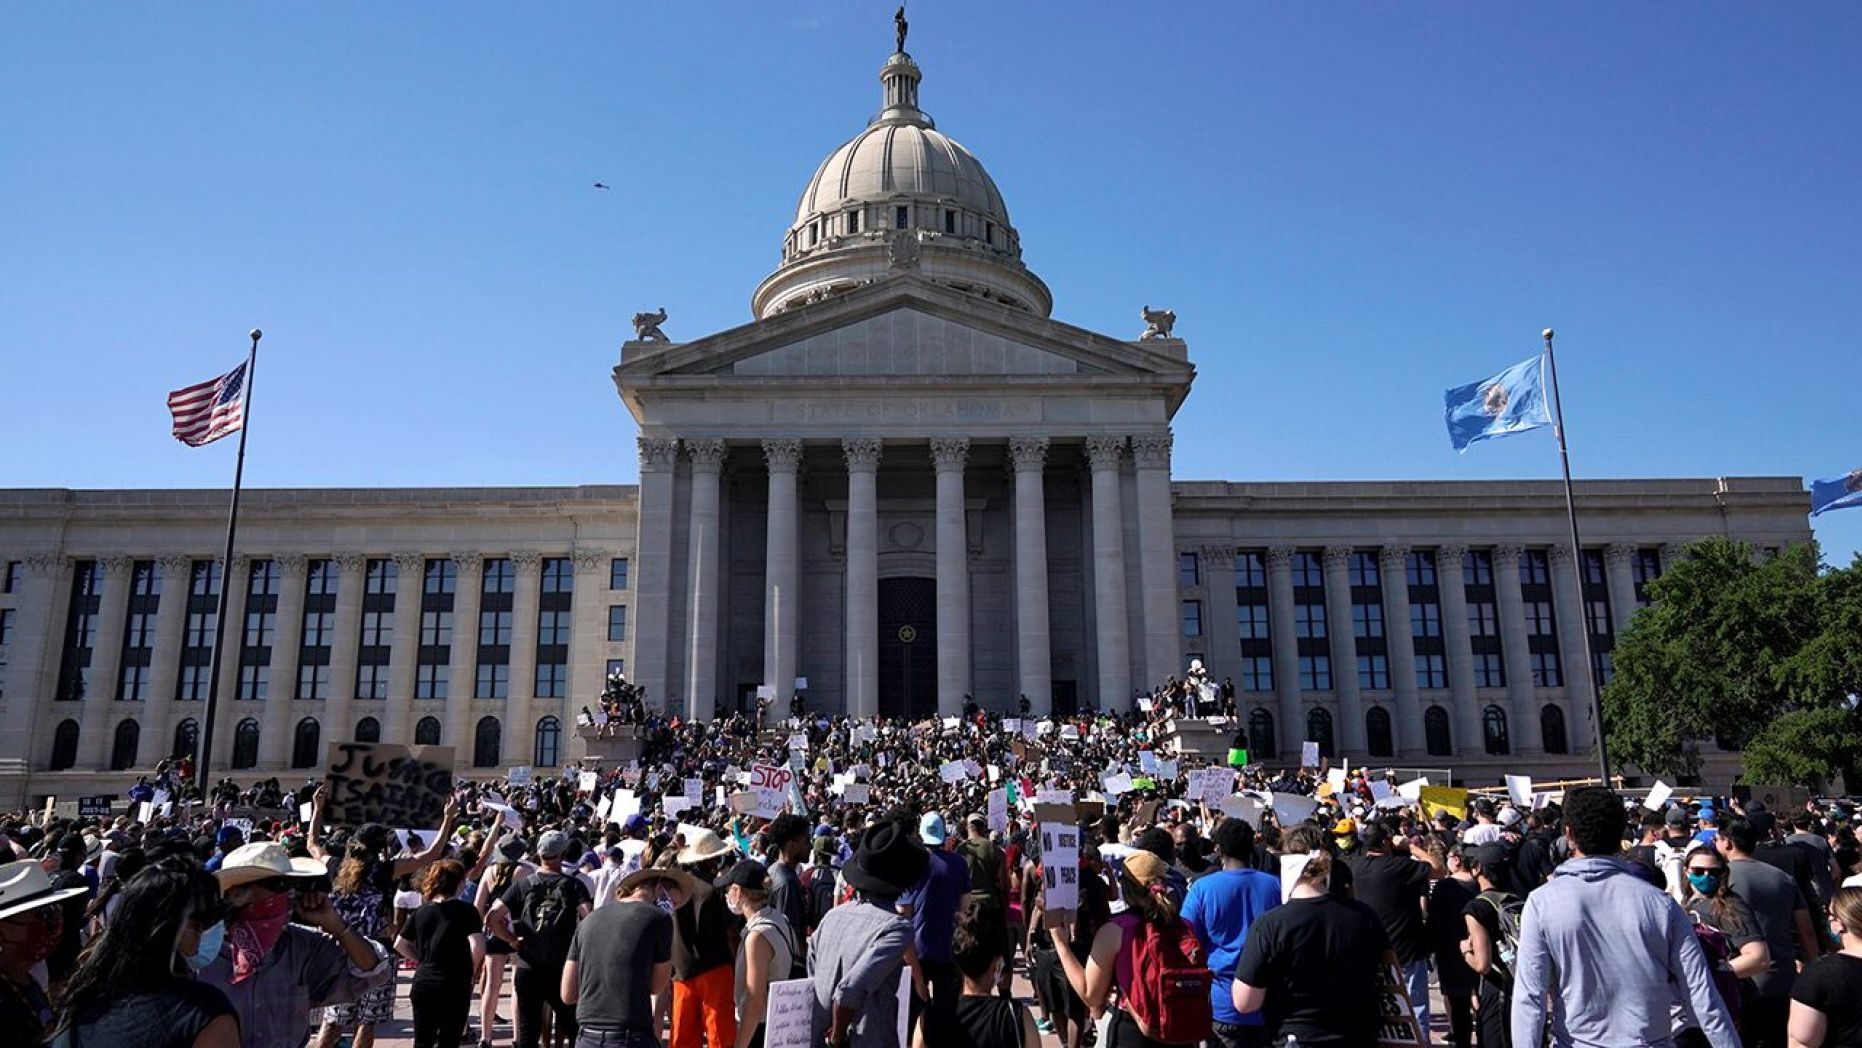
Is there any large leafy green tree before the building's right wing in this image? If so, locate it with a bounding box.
[1603,538,1838,776]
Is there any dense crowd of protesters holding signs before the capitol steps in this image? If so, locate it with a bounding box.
[0,681,1862,1048]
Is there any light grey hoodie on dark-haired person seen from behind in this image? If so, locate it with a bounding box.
[1512,858,1739,1048]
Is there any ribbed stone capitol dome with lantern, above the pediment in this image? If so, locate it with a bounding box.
[750,50,1054,316]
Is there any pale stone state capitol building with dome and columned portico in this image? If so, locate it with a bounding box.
[0,36,1810,804]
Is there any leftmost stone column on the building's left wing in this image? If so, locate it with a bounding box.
[0,553,70,778]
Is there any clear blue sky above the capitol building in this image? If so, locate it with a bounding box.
[0,0,1862,562]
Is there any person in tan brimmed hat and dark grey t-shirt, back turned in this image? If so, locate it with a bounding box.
[562,867,695,1048]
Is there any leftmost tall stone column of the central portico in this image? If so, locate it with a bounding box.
[629,437,680,718]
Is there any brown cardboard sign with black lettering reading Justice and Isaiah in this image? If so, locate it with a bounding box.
[324,743,452,830]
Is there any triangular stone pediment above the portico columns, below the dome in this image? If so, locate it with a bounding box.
[614,277,1194,385]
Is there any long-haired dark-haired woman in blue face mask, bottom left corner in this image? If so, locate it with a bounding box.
[48,858,238,1048]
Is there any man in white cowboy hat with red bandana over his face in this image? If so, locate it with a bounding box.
[201,841,395,1048]
